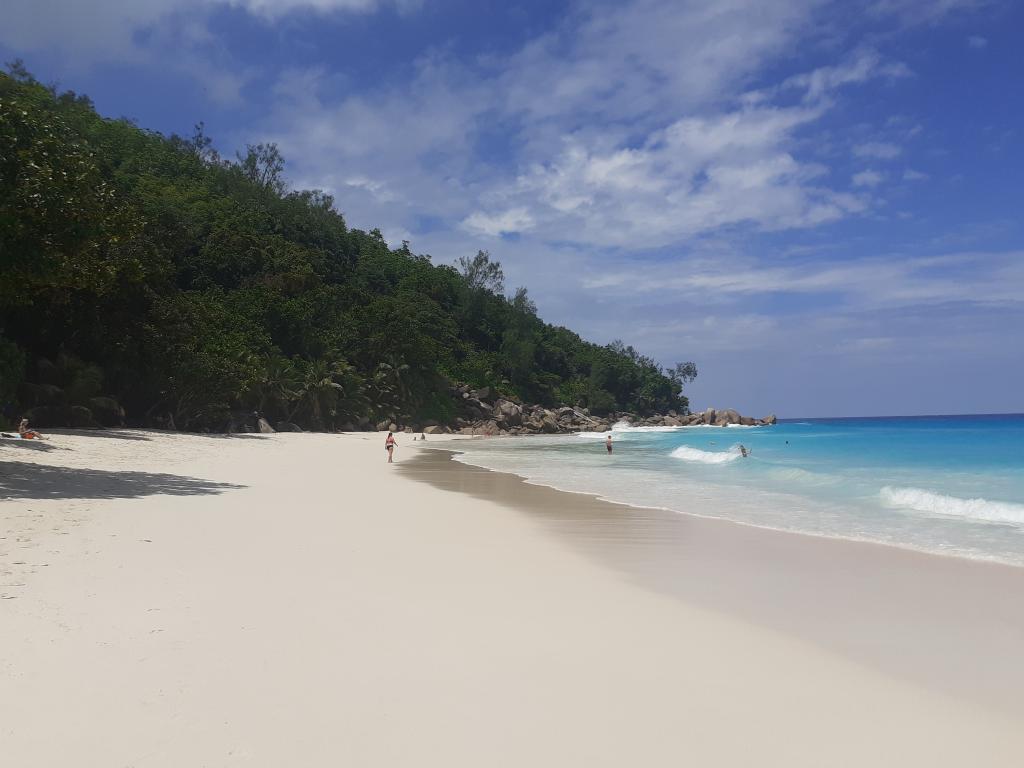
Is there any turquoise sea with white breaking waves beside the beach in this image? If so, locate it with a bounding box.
[459,415,1024,565]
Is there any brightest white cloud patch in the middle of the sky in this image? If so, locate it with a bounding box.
[481,100,864,248]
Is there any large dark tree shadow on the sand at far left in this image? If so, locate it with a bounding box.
[0,462,246,499]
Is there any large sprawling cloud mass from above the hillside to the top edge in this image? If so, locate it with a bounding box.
[256,0,899,250]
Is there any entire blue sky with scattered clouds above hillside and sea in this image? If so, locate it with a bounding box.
[0,0,1024,418]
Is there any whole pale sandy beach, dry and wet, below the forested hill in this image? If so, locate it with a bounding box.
[0,430,1024,767]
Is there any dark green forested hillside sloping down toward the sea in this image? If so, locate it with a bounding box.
[0,66,695,430]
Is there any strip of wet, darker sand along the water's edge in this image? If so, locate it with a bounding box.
[401,446,1024,717]
